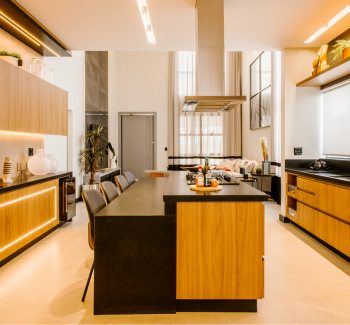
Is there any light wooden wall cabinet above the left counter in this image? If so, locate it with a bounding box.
[0,59,68,136]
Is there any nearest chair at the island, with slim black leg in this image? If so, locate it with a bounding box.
[81,190,106,301]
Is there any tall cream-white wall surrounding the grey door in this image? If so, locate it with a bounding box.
[108,52,169,170]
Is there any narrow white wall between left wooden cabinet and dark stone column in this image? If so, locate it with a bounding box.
[44,51,85,197]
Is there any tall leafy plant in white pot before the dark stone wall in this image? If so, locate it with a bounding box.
[79,125,113,191]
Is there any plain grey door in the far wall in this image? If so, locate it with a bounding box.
[121,115,154,178]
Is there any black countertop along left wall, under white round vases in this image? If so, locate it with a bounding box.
[0,172,72,194]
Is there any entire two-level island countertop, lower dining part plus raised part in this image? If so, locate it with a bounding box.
[96,171,268,217]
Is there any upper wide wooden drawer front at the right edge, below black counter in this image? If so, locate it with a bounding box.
[316,182,350,222]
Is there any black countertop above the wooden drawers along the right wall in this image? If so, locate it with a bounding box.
[285,167,350,186]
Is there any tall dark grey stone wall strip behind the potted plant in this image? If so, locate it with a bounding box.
[85,51,108,168]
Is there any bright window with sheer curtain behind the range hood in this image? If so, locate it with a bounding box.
[177,52,223,157]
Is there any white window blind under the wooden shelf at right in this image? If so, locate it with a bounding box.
[323,83,350,156]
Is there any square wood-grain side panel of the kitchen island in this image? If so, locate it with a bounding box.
[176,202,264,299]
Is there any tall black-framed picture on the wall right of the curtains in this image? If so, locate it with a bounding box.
[250,52,271,130]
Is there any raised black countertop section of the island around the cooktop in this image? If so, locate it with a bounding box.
[164,171,268,203]
